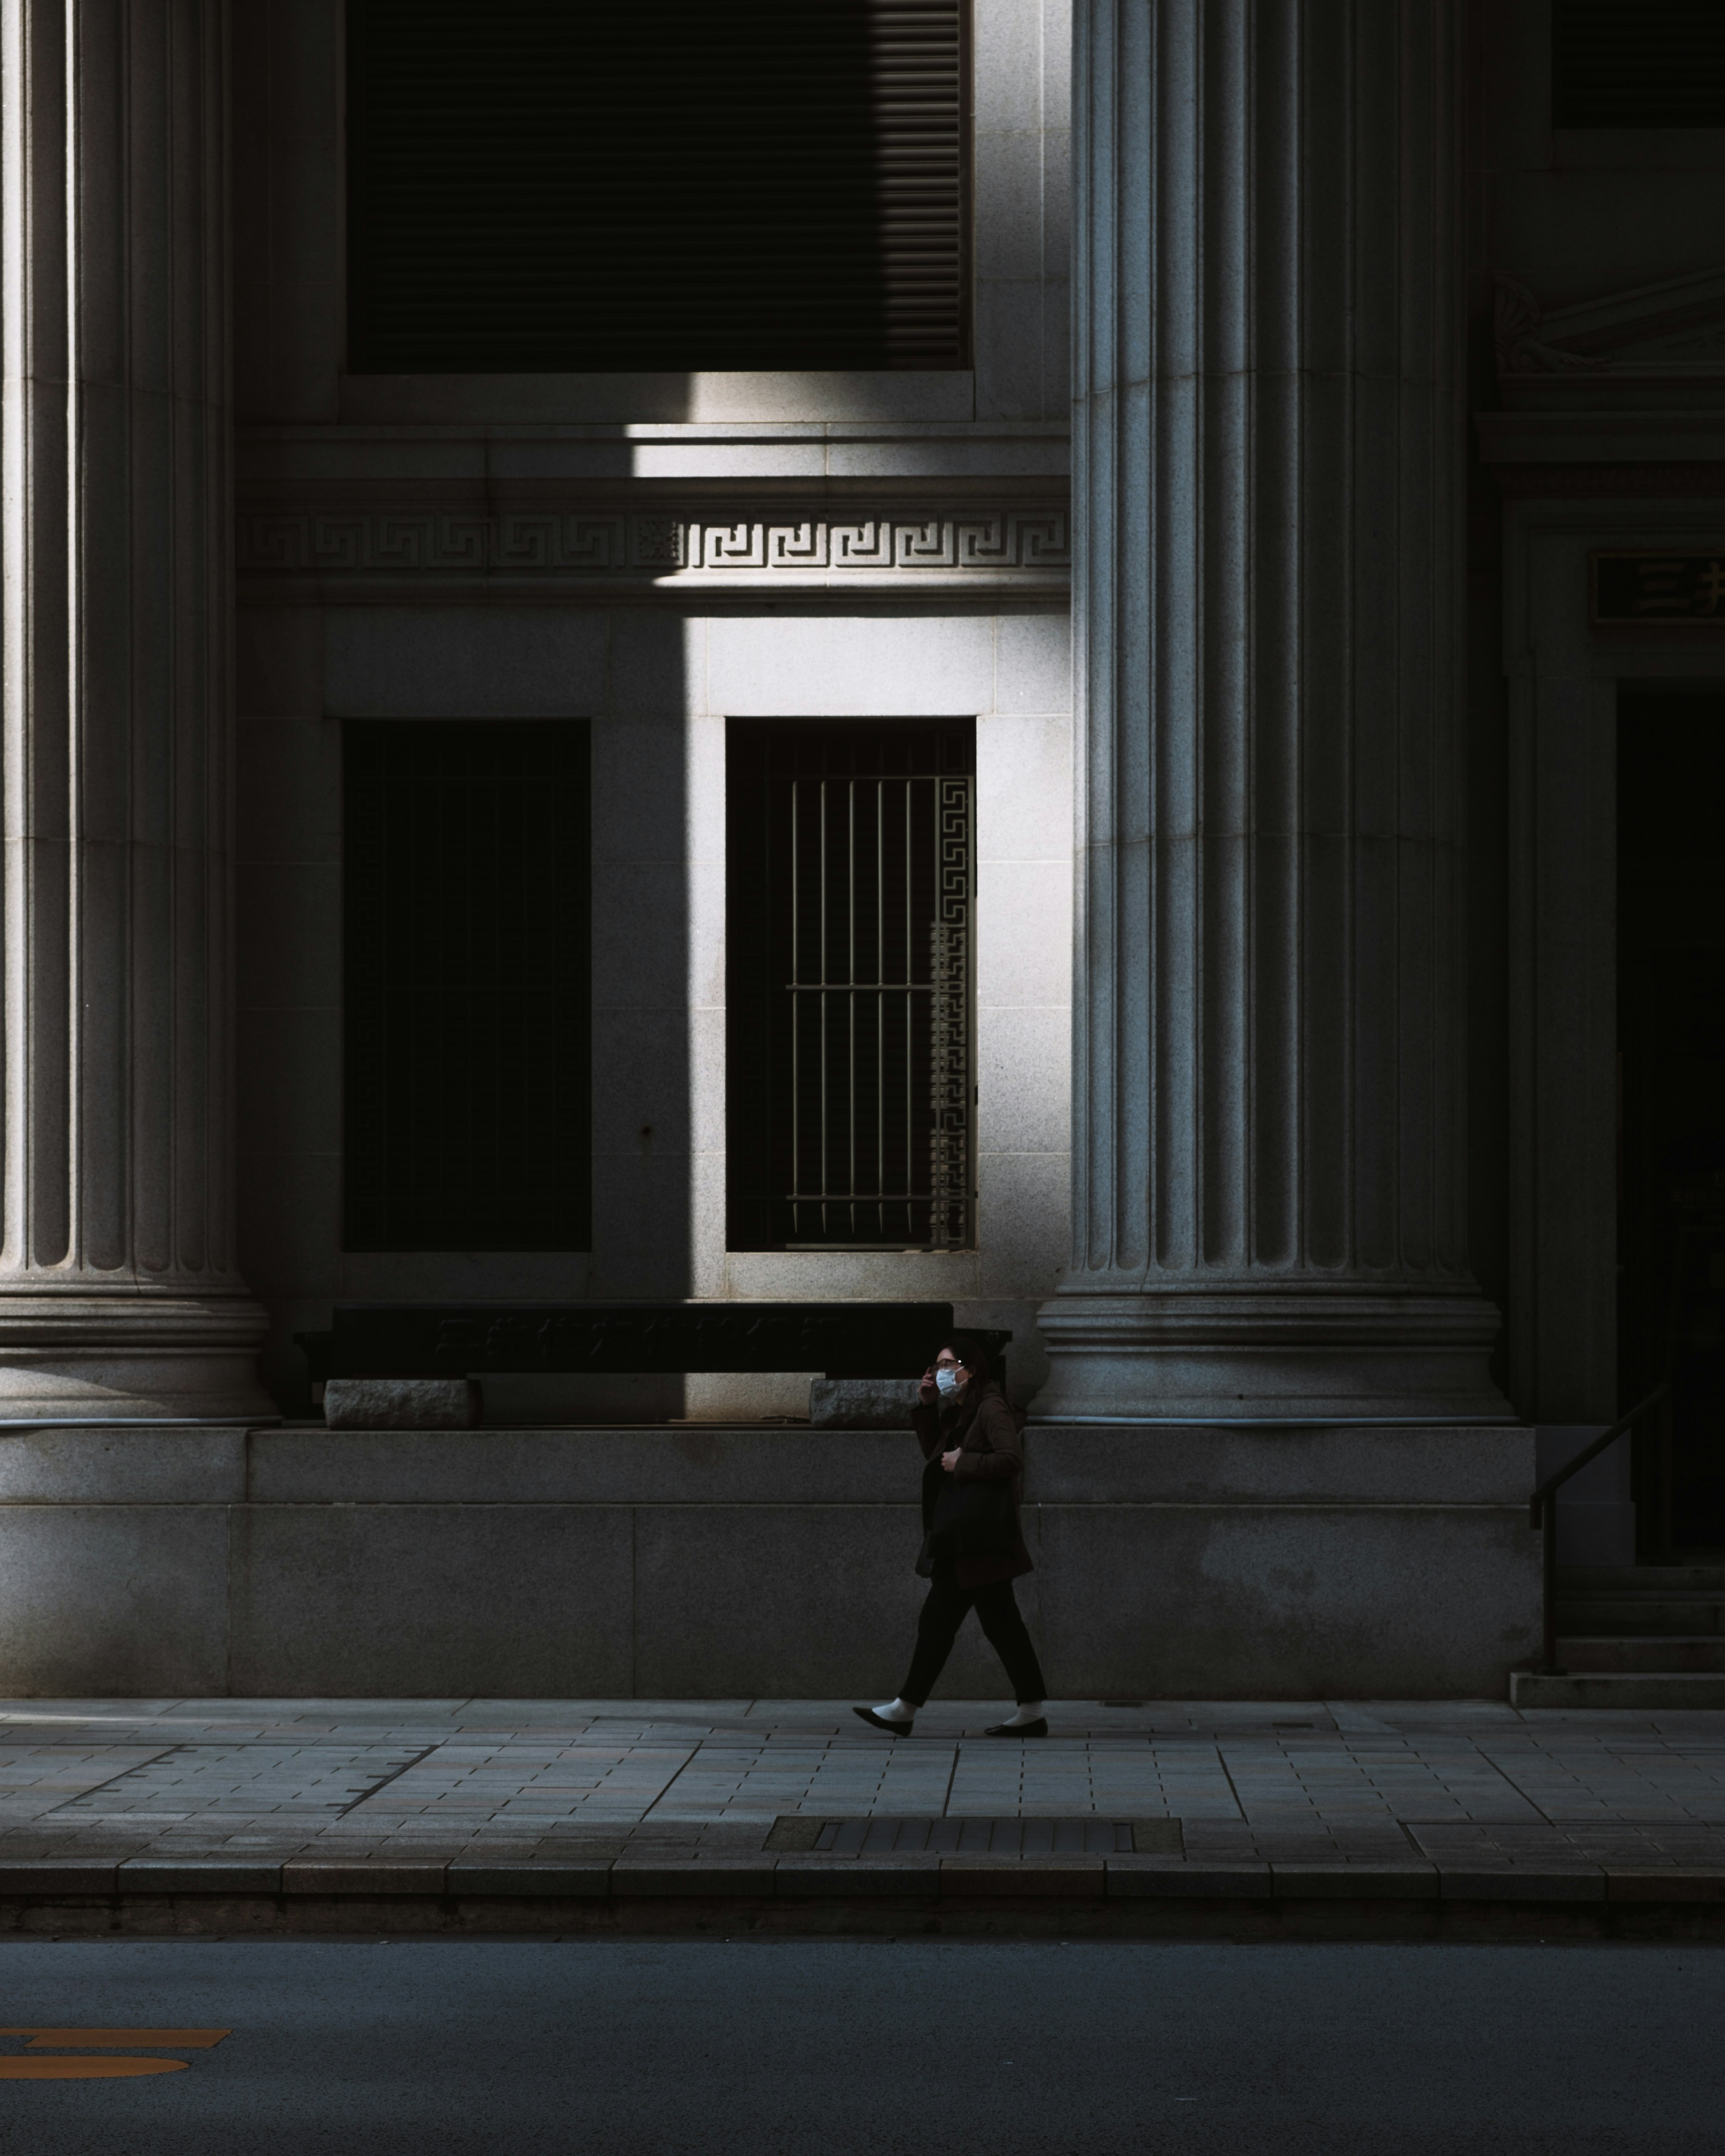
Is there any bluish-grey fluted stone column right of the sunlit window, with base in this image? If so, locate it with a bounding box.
[1037,0,1507,1421]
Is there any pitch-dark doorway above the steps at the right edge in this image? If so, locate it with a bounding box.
[1617,690,1725,1559]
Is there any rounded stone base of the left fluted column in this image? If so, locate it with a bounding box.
[0,1287,280,1423]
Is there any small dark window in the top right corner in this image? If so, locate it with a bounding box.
[1550,0,1725,127]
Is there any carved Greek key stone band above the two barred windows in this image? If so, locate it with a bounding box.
[237,498,1072,601]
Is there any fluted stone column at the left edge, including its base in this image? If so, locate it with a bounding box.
[0,0,270,1418]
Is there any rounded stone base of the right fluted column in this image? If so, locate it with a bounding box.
[1033,1287,1518,1423]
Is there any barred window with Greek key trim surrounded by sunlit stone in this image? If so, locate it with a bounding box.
[727,720,977,1250]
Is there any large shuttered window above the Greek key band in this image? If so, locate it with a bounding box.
[347,0,968,373]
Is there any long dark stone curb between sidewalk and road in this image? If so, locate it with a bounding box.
[0,1856,1725,1904]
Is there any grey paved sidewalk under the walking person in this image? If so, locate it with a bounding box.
[0,1699,1725,1871]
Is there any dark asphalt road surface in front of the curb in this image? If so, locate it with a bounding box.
[0,1940,1725,2156]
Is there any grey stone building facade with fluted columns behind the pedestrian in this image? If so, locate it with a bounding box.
[0,0,1725,1697]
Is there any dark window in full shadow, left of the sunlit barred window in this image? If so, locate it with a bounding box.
[343,720,591,1250]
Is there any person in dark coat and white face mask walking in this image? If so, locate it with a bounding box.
[852,1332,1048,1738]
